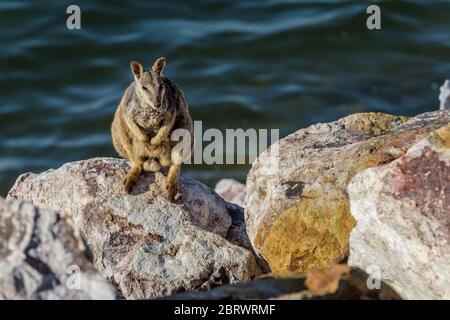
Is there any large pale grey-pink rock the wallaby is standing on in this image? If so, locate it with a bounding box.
[9,158,259,299]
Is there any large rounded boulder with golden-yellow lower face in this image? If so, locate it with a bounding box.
[245,111,450,272]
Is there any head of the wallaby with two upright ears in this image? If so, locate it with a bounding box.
[130,57,166,109]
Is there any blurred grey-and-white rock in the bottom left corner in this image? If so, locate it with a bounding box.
[0,198,116,299]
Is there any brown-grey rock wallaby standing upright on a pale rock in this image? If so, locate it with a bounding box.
[111,57,194,201]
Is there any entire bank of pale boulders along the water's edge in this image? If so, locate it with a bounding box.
[0,110,450,299]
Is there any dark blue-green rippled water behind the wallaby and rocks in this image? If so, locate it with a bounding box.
[0,0,450,196]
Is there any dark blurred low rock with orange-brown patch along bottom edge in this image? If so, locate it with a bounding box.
[165,265,400,300]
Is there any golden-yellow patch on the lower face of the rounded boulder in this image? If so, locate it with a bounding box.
[255,191,354,272]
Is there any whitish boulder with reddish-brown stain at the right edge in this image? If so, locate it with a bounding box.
[348,124,450,299]
